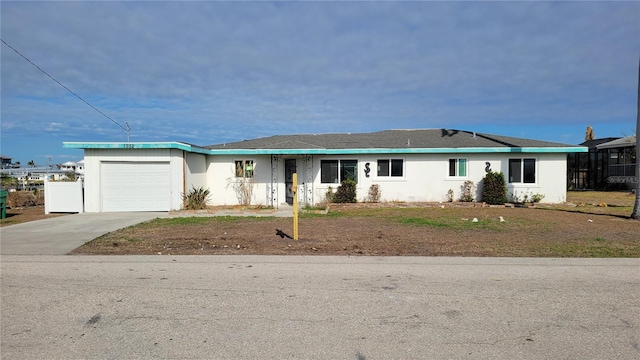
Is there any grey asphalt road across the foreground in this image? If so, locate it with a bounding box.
[0,256,640,360]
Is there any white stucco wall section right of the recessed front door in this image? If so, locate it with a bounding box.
[314,154,566,203]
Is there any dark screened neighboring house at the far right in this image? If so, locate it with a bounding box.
[567,136,636,190]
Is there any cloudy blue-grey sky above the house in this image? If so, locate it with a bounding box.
[0,0,640,165]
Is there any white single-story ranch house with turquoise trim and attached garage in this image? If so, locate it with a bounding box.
[64,129,588,212]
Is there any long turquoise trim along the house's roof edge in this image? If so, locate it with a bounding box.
[62,142,589,155]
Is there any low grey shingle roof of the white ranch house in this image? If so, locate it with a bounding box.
[205,129,574,150]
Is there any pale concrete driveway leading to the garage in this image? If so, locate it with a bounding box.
[0,212,168,255]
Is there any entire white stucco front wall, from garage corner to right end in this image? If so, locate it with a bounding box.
[202,153,566,207]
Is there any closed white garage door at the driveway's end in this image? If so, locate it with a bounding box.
[101,162,171,212]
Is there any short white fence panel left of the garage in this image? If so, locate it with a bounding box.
[44,178,84,214]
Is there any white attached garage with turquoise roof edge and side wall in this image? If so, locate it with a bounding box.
[64,142,209,213]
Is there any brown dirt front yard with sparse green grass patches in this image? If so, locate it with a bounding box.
[74,193,640,257]
